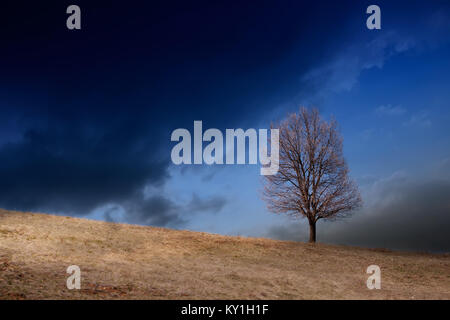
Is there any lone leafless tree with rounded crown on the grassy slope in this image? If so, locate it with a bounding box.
[263,108,362,242]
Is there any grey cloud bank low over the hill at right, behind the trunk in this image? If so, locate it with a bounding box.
[268,175,450,252]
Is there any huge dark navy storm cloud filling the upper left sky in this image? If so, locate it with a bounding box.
[0,1,352,225]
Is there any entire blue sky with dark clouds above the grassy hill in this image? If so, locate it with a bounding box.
[0,1,450,252]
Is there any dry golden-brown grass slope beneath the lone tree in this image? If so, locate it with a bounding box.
[0,210,450,299]
